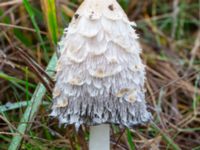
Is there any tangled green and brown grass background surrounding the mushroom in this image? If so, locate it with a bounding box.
[0,0,200,150]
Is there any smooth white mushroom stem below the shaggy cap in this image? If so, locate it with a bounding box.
[89,124,110,150]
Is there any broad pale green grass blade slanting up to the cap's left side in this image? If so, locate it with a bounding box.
[9,54,57,150]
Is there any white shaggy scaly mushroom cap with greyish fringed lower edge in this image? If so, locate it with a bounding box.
[51,0,151,128]
